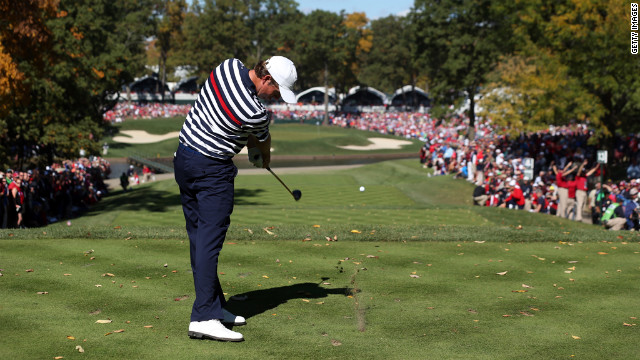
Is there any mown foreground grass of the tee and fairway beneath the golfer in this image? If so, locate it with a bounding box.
[0,160,640,359]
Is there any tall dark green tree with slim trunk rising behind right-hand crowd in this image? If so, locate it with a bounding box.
[412,0,511,139]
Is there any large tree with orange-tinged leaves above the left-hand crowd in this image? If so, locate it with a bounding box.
[0,0,150,167]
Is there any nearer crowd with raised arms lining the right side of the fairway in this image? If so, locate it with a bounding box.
[420,129,640,230]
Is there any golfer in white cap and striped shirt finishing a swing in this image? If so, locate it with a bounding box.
[173,56,297,341]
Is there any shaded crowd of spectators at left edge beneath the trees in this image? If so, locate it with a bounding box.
[0,157,111,229]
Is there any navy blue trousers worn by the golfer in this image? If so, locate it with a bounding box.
[173,144,238,321]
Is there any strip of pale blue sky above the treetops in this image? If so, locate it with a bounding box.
[296,0,413,20]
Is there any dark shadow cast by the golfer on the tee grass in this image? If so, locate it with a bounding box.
[227,283,355,318]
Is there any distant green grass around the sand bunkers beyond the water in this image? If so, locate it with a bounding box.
[105,117,422,157]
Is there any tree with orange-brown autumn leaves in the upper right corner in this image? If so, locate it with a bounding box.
[515,0,640,138]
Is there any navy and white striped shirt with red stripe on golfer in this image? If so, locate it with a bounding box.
[179,59,271,160]
